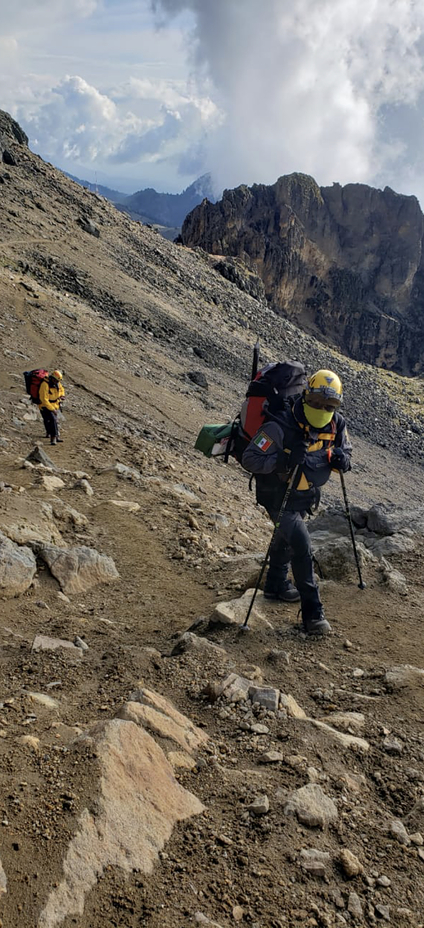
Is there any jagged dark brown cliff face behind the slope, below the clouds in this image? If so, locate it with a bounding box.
[181,174,424,374]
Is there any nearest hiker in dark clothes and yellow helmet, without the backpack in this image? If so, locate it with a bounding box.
[242,370,352,635]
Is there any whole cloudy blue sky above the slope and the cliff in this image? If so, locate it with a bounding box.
[0,0,424,206]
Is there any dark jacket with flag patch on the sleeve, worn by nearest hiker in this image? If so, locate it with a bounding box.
[242,399,352,514]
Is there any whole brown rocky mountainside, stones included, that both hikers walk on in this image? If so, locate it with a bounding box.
[0,114,424,928]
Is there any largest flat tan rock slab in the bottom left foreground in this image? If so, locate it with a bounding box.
[37,719,204,928]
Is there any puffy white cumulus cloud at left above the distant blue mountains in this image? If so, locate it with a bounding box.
[18,76,218,185]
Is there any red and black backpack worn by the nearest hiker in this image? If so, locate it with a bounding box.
[227,361,307,463]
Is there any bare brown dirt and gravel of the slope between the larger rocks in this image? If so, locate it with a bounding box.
[0,130,424,928]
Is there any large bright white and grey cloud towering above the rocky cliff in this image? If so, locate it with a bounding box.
[152,0,424,202]
